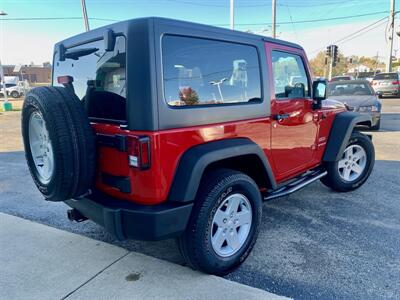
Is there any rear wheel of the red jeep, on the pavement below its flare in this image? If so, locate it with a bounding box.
[178,169,262,275]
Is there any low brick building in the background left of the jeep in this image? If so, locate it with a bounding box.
[3,65,51,84]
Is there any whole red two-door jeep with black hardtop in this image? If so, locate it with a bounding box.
[22,18,375,274]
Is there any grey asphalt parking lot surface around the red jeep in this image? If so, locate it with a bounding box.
[0,99,400,299]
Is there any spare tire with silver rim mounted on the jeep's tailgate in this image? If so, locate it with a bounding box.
[21,87,96,201]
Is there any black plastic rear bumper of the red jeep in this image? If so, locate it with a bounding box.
[65,196,193,241]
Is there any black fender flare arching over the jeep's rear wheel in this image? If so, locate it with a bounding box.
[168,138,277,202]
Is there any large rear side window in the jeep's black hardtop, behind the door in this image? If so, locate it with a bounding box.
[162,35,261,106]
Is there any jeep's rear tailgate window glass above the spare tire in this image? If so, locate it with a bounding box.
[53,36,126,122]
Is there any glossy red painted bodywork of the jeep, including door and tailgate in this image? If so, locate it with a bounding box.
[92,43,343,205]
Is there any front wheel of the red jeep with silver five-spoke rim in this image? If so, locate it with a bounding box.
[321,132,375,192]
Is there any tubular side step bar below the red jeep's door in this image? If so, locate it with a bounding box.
[264,170,328,201]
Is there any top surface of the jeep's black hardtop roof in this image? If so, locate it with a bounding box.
[56,17,303,49]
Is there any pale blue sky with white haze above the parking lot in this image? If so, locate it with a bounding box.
[0,0,400,64]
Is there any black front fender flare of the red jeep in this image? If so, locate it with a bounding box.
[322,111,371,161]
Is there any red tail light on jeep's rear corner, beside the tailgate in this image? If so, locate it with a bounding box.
[127,136,151,170]
